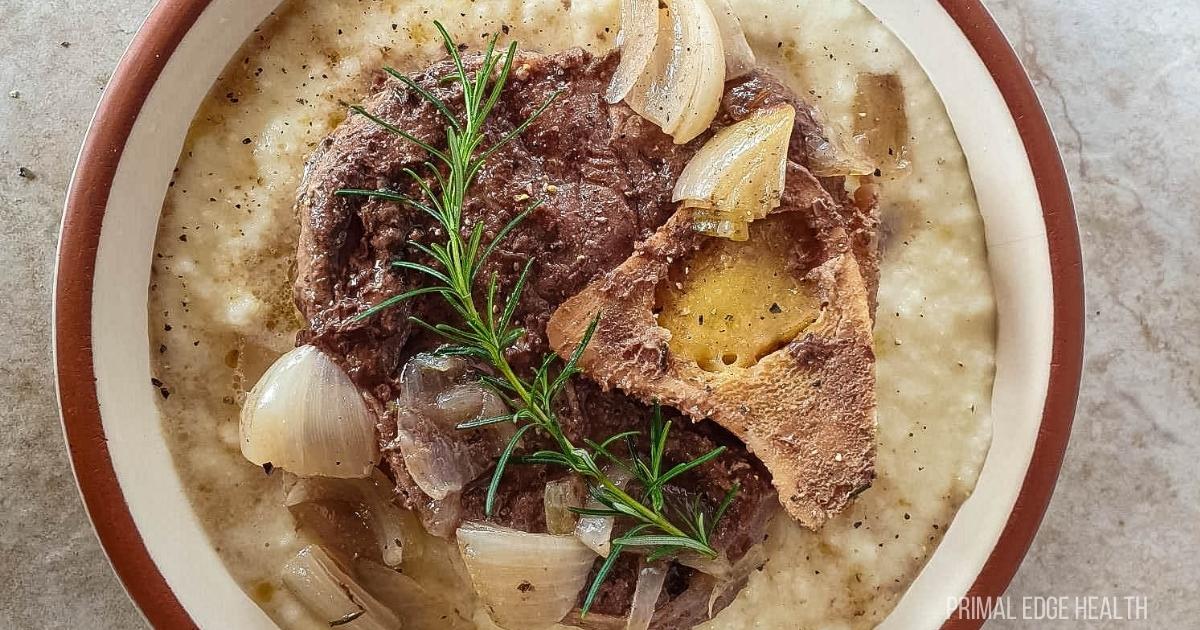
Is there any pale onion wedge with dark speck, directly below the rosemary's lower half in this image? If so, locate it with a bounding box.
[457,522,596,630]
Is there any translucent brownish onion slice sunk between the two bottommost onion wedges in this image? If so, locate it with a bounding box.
[354,560,475,630]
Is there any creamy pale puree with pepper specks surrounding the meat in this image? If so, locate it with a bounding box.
[150,0,995,629]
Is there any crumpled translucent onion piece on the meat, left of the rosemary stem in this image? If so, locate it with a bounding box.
[394,354,515,502]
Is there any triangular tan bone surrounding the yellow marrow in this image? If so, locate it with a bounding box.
[548,206,875,529]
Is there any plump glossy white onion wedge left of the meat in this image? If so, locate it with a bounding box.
[241,346,379,478]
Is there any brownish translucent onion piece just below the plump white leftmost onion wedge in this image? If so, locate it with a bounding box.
[283,470,420,566]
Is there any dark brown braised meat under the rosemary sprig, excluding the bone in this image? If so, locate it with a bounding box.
[295,49,874,628]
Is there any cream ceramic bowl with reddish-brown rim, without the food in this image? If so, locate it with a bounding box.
[54,0,1084,630]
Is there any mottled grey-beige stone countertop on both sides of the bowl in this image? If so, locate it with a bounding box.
[0,0,1200,629]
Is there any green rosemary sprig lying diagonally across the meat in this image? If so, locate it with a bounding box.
[337,22,738,614]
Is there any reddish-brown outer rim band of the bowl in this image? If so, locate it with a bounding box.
[53,0,1085,630]
